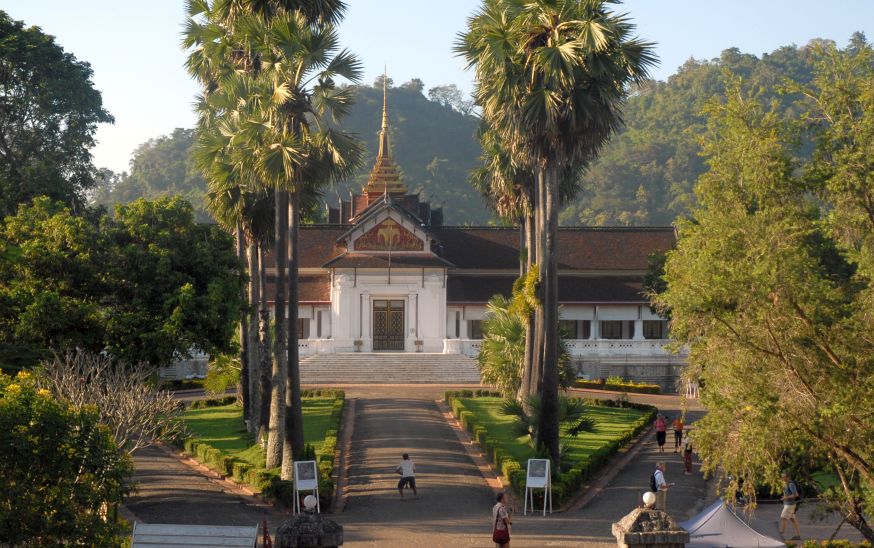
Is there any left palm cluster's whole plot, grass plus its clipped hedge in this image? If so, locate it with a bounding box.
[182,390,345,507]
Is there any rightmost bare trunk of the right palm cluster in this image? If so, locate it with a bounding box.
[537,160,559,466]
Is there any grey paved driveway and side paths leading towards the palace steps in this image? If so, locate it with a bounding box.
[127,385,857,548]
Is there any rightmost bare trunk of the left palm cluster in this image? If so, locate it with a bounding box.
[282,189,304,479]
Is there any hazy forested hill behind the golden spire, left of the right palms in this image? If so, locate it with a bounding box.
[92,80,490,224]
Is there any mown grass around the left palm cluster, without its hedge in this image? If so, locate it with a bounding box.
[184,398,339,468]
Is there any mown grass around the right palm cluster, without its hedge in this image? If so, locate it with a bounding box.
[461,398,645,466]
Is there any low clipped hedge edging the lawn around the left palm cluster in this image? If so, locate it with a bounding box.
[182,389,346,508]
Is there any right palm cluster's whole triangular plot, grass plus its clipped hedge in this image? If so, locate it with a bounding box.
[446,391,656,506]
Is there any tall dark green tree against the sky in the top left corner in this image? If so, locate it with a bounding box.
[0,10,113,217]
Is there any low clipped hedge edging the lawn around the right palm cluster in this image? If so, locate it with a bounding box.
[445,390,657,506]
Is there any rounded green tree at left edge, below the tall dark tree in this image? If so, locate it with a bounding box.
[0,197,109,370]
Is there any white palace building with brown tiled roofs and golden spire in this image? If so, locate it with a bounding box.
[280,83,682,386]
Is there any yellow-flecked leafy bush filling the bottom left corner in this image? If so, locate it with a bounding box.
[0,372,133,546]
